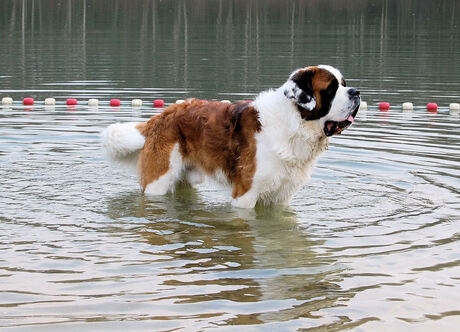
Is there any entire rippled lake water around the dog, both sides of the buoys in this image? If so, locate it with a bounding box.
[0,0,460,331]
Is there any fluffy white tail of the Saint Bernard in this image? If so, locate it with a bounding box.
[102,122,145,162]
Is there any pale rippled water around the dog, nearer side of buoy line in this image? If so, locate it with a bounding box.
[0,107,460,331]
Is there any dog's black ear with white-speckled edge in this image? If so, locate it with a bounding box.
[284,69,316,111]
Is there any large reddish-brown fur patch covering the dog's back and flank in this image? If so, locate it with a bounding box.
[136,99,261,198]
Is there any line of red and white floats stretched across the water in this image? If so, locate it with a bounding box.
[2,97,460,115]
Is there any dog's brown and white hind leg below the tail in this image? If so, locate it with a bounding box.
[140,143,184,195]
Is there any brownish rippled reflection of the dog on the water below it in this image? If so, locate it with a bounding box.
[108,188,340,324]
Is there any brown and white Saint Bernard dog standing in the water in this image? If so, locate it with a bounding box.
[102,65,361,208]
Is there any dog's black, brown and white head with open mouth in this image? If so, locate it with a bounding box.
[282,65,361,136]
